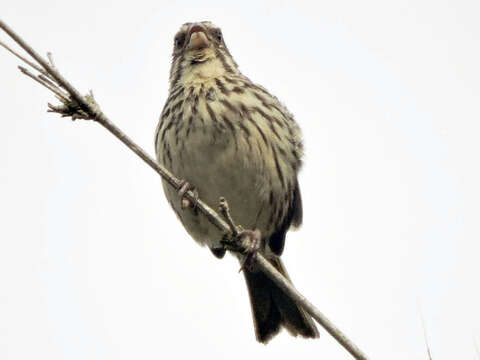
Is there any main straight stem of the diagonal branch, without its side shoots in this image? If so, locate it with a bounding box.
[0,20,367,360]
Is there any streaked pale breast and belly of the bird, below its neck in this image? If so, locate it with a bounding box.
[156,72,301,253]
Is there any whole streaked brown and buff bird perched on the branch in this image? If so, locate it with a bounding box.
[155,21,319,344]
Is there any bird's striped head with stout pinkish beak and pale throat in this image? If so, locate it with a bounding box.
[170,21,238,88]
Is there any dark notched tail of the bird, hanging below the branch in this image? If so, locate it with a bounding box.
[244,258,319,344]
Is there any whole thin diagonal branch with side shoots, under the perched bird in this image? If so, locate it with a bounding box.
[0,20,367,360]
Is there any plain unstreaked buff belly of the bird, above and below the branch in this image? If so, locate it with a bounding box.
[164,130,270,247]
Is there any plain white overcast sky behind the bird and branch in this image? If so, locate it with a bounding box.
[0,0,480,360]
